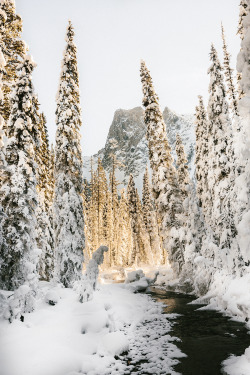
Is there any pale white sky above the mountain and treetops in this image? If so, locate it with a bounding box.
[16,0,240,155]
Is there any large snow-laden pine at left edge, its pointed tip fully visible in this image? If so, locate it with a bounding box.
[0,56,39,308]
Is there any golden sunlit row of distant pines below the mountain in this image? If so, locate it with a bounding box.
[84,155,166,268]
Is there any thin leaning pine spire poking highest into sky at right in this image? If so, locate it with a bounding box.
[221,24,239,116]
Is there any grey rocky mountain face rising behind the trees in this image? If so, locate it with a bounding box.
[84,107,195,192]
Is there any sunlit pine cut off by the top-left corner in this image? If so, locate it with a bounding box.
[0,0,27,125]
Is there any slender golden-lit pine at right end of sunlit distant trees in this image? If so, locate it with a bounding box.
[142,168,163,264]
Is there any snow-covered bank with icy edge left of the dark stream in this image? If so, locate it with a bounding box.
[0,282,183,375]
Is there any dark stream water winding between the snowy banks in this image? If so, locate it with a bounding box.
[149,288,250,375]
